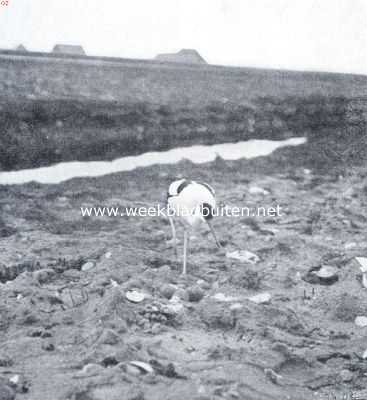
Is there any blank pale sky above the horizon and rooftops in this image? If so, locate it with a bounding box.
[0,0,367,74]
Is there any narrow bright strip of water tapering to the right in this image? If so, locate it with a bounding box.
[0,137,307,185]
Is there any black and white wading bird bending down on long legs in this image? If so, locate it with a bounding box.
[167,179,221,274]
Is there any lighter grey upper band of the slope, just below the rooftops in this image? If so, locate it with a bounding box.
[0,52,367,107]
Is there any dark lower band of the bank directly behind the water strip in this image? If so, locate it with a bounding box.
[0,96,367,170]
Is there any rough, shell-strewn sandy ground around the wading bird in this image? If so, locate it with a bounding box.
[0,147,367,400]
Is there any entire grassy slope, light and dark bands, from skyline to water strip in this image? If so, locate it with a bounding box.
[0,54,367,170]
